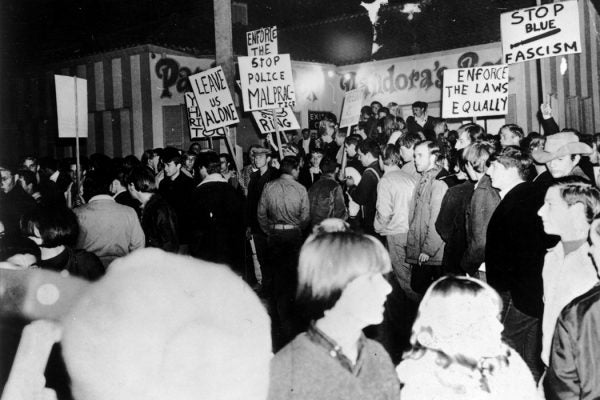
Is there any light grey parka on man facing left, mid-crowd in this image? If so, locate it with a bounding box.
[406,168,448,265]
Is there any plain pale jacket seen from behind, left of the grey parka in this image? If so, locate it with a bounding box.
[374,167,417,236]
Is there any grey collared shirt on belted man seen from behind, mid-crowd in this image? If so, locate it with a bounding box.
[257,174,310,233]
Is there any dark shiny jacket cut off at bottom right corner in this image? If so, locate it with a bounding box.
[544,284,600,400]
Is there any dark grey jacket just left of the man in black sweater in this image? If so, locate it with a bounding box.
[460,175,500,276]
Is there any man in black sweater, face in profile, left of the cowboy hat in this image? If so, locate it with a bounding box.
[485,146,546,380]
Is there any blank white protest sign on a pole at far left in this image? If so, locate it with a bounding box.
[54,75,88,138]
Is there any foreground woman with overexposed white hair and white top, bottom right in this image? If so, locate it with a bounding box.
[396,277,537,400]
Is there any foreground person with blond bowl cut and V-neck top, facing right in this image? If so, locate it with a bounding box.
[269,229,400,400]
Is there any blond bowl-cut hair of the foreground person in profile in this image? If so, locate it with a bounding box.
[297,232,392,320]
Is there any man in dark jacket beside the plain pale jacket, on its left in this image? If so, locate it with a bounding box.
[349,139,383,236]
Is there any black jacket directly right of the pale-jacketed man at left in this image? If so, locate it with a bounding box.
[142,193,179,253]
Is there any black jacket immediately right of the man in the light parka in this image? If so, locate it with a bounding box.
[435,181,475,275]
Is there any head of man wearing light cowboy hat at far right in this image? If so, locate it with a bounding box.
[531,131,592,181]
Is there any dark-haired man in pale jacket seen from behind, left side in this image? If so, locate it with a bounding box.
[74,171,146,267]
